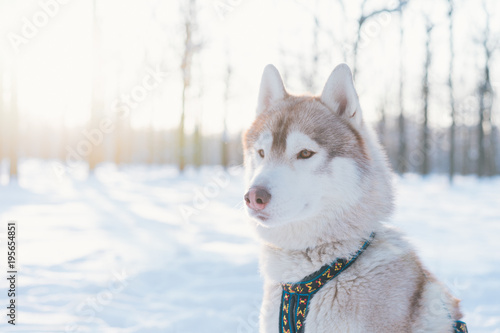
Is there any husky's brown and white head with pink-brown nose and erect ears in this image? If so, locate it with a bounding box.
[243,65,392,247]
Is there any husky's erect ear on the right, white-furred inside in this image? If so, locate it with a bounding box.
[321,64,362,125]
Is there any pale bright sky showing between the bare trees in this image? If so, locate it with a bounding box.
[0,0,500,133]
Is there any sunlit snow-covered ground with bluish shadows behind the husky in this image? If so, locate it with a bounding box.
[0,160,500,333]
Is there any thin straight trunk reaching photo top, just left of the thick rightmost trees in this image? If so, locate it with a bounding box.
[448,0,456,183]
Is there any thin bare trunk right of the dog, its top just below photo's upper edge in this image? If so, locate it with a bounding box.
[420,17,434,175]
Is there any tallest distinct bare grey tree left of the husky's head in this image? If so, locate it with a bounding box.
[179,0,201,171]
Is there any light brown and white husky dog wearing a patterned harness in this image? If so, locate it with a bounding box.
[243,64,462,333]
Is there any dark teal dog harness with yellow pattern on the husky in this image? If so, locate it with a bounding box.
[279,233,468,333]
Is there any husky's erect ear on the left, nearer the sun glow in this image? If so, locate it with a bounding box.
[257,65,287,115]
